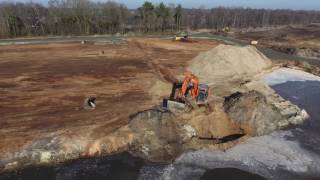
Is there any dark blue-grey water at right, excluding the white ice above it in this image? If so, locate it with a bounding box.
[272,81,320,154]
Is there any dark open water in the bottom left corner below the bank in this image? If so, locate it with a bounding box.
[0,153,147,180]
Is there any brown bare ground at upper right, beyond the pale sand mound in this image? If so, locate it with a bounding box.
[231,24,320,60]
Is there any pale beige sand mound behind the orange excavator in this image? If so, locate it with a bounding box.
[188,45,271,83]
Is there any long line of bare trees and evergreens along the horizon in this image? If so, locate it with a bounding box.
[0,0,320,38]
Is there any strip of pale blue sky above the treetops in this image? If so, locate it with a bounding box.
[0,0,320,10]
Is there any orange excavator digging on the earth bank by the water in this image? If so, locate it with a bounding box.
[163,71,209,111]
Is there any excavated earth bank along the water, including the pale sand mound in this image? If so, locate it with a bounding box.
[0,45,308,171]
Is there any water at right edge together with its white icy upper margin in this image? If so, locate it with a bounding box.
[265,68,320,179]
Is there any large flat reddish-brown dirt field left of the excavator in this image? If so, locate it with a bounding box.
[0,39,217,155]
